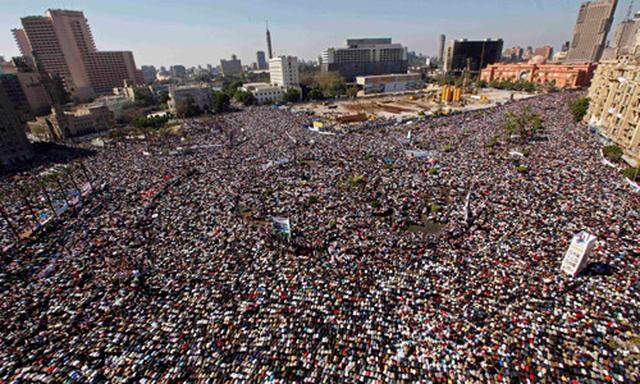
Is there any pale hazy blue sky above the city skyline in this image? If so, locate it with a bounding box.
[0,0,630,66]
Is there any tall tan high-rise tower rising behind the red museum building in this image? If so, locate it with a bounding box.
[565,0,618,63]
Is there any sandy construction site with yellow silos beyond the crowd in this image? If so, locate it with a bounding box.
[292,85,534,126]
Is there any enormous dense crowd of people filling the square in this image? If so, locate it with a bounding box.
[0,94,640,383]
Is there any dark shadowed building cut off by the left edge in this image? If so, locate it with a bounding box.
[0,80,33,167]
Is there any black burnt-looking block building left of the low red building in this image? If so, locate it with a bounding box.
[444,39,503,75]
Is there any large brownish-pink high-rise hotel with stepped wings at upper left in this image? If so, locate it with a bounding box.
[13,9,143,100]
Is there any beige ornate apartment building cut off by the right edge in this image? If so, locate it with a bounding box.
[585,57,640,162]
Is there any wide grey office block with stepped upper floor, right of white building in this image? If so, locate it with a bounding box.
[321,38,408,81]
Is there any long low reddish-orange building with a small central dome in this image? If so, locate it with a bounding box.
[480,60,596,89]
